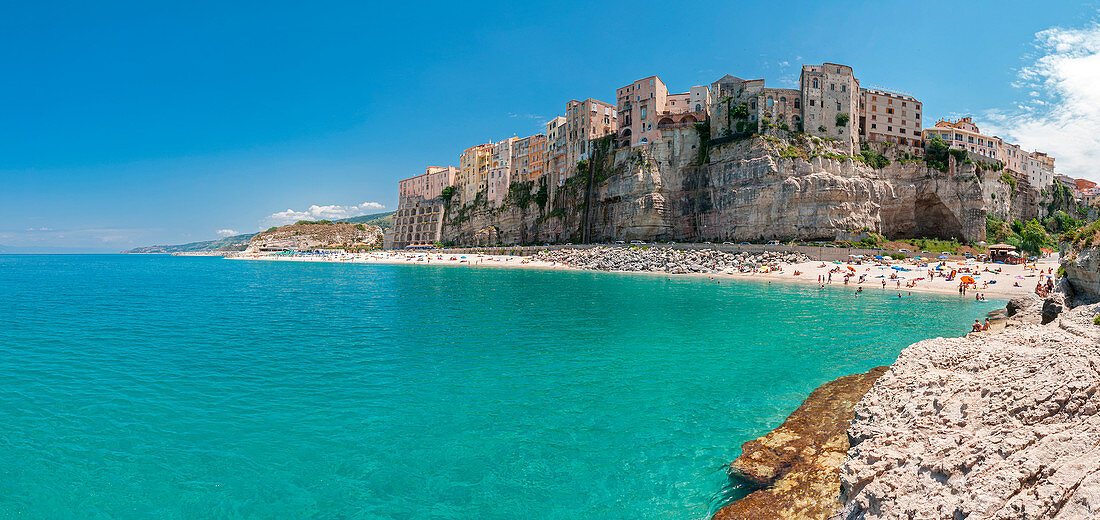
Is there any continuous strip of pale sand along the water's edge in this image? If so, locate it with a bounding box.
[226,252,1058,300]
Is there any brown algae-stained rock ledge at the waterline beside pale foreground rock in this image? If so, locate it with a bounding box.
[714,366,887,520]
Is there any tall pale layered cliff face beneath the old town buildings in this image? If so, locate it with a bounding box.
[435,129,1021,244]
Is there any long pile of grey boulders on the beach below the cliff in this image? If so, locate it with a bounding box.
[534,247,810,274]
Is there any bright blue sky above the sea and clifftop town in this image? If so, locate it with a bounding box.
[0,1,1100,251]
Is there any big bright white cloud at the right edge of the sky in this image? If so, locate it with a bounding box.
[983,23,1100,180]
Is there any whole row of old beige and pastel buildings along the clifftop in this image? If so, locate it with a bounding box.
[387,63,1082,247]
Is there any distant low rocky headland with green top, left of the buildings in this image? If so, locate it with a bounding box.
[245,220,382,253]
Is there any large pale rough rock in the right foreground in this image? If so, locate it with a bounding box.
[837,301,1100,520]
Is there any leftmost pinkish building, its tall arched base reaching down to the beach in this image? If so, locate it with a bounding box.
[384,166,459,248]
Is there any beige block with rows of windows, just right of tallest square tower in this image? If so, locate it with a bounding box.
[859,88,924,154]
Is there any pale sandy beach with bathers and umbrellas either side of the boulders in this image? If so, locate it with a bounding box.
[231,251,1058,299]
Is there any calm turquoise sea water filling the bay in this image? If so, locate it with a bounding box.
[0,252,1001,519]
